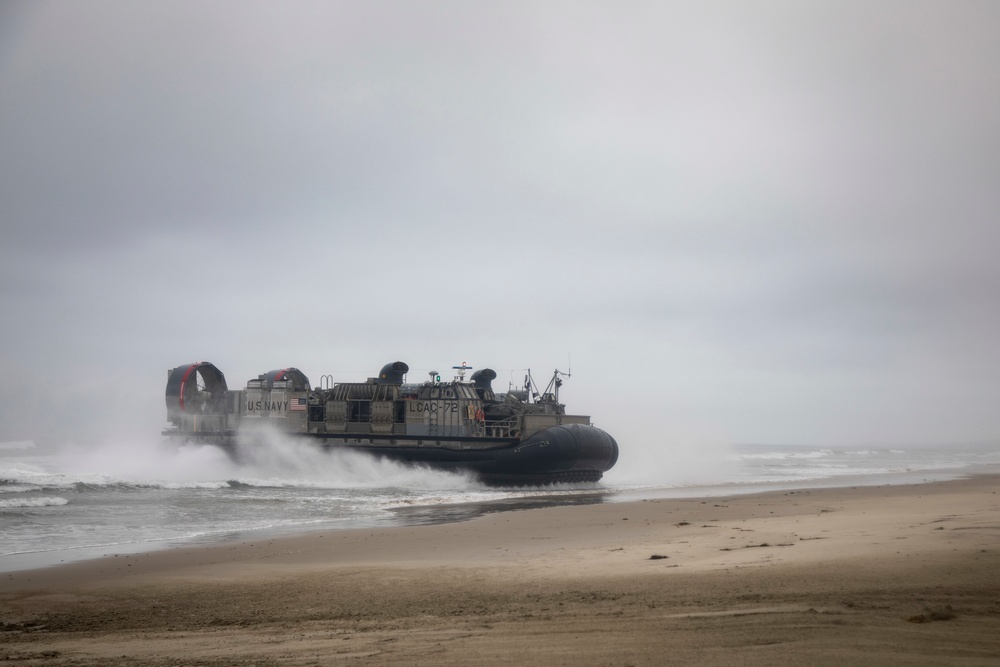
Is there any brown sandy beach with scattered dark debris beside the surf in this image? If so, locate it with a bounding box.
[0,475,1000,666]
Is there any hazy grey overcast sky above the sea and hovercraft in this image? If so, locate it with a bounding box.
[0,0,1000,461]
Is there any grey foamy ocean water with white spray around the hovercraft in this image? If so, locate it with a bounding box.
[0,440,1000,572]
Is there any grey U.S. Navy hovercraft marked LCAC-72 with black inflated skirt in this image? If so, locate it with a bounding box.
[163,361,618,486]
